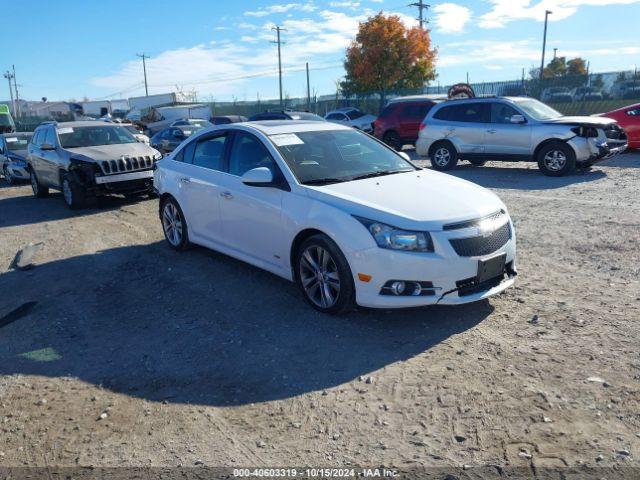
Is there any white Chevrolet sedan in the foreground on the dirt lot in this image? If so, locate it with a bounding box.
[154,121,516,313]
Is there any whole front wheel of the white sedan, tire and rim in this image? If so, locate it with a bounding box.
[294,235,356,315]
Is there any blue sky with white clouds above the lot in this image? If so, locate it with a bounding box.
[0,0,640,101]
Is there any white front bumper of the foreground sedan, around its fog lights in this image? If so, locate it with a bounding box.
[348,225,516,308]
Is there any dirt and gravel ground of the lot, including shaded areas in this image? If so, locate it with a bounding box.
[0,154,640,472]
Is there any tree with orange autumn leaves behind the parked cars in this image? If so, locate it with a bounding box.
[343,12,436,109]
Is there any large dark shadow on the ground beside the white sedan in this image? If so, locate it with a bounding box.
[0,242,492,405]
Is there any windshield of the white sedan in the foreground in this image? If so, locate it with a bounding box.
[270,130,416,185]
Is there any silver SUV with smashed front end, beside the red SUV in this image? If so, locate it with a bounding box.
[416,97,627,177]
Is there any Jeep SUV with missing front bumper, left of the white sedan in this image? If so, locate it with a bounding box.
[27,121,162,209]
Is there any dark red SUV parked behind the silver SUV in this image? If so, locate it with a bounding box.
[373,97,436,150]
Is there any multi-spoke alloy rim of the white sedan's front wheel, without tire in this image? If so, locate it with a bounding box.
[299,245,340,308]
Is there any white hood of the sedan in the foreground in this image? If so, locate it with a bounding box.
[307,170,506,231]
